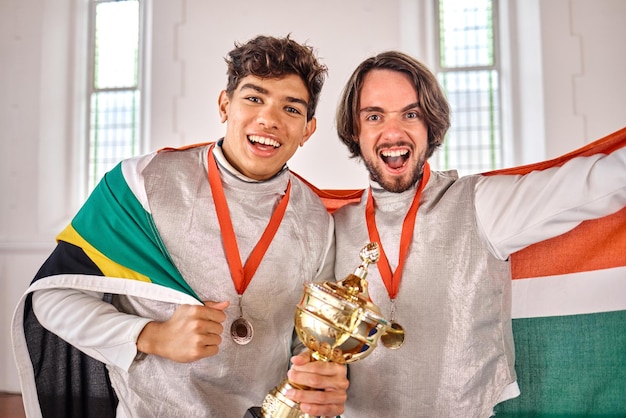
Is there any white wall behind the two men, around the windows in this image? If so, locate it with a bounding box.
[0,0,626,391]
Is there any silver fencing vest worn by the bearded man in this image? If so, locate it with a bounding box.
[334,171,515,418]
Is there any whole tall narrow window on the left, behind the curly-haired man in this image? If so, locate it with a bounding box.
[88,0,142,190]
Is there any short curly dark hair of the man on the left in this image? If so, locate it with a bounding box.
[224,35,328,121]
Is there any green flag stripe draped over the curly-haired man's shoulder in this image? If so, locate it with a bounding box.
[72,164,199,300]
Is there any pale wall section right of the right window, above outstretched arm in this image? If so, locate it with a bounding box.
[540,0,626,157]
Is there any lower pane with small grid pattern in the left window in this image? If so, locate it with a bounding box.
[89,90,139,187]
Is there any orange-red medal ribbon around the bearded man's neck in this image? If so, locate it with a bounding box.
[365,162,430,300]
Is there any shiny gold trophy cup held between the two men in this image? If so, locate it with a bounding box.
[261,242,404,418]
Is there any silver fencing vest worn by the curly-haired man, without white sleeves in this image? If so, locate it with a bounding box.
[109,143,332,417]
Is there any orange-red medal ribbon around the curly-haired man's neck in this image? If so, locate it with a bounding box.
[208,145,291,295]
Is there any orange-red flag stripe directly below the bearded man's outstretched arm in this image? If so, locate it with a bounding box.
[511,208,626,279]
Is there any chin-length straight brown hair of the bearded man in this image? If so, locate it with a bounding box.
[336,51,450,159]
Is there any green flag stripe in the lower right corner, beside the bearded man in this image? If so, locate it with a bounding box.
[495,311,626,418]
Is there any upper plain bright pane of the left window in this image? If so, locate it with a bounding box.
[94,0,139,89]
